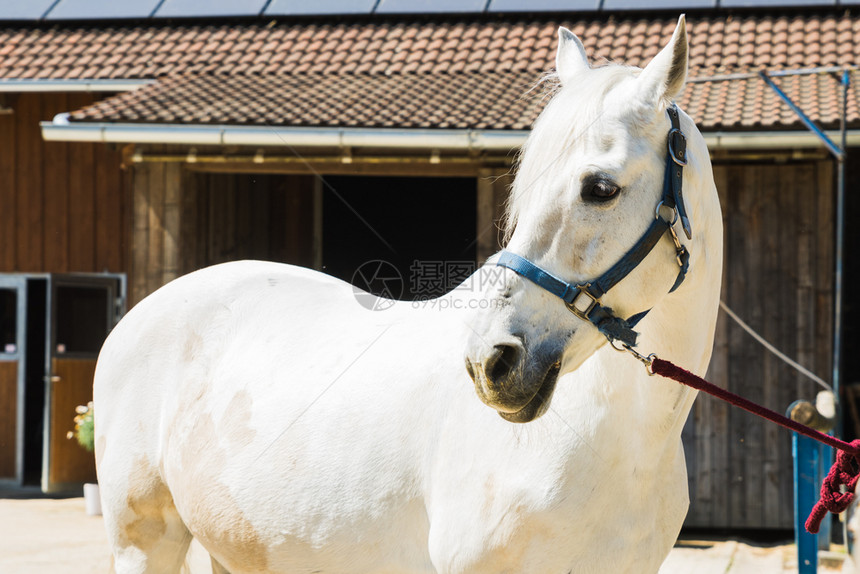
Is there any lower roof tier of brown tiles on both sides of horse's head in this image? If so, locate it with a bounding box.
[69,71,860,130]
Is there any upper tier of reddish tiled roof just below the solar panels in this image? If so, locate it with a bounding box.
[0,11,860,79]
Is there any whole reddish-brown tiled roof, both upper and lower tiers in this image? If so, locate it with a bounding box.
[6,10,860,129]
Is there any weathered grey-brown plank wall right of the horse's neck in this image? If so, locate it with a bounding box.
[684,161,834,529]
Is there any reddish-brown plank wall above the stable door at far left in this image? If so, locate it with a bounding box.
[0,93,128,273]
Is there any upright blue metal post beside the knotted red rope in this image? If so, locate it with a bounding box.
[791,433,828,574]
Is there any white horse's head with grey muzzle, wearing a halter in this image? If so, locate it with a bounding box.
[466,16,719,422]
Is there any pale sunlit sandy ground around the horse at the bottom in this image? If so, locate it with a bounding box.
[0,495,854,574]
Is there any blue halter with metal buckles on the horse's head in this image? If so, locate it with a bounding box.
[496,104,692,347]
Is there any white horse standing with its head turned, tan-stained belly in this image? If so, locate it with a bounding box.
[95,18,722,574]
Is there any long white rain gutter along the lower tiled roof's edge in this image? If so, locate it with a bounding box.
[41,114,860,151]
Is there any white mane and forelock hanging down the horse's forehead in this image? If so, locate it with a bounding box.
[501,63,640,244]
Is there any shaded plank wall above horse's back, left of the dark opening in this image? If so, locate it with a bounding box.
[130,168,316,304]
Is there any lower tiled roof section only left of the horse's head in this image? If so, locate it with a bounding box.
[69,72,541,130]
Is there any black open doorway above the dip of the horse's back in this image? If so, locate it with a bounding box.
[322,176,477,300]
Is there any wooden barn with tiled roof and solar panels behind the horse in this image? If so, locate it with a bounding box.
[0,0,860,529]
